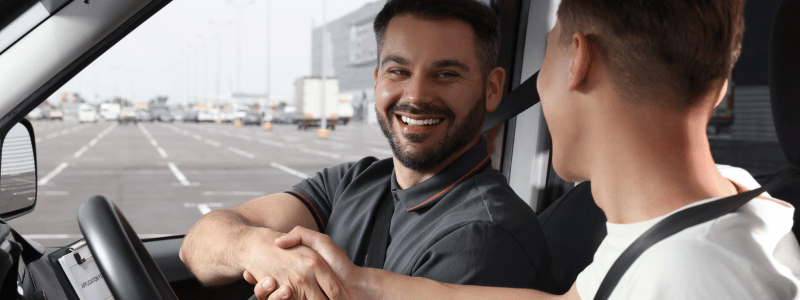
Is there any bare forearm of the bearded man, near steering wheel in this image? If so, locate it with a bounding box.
[180,209,277,285]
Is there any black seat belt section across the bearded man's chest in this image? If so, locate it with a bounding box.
[364,191,394,269]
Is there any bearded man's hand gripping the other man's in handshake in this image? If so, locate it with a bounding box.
[241,229,349,299]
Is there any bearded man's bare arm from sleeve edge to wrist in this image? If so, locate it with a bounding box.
[180,193,319,285]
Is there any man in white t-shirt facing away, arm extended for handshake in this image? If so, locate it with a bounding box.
[256,0,800,300]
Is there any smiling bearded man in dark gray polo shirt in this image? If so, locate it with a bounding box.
[180,0,549,296]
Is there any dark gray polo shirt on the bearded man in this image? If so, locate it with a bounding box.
[288,137,550,289]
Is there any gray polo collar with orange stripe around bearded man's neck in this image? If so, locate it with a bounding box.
[391,135,491,211]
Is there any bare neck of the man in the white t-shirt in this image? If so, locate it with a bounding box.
[589,102,736,224]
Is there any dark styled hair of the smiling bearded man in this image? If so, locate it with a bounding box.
[373,0,500,75]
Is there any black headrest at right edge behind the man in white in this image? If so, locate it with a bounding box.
[769,0,800,168]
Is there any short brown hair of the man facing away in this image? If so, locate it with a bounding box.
[558,0,744,108]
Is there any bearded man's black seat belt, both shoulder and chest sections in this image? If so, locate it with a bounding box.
[364,71,539,269]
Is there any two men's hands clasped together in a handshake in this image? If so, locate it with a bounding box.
[243,227,357,300]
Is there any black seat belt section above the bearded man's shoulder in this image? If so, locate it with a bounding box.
[483,71,539,131]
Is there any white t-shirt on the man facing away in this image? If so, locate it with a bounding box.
[576,165,800,300]
